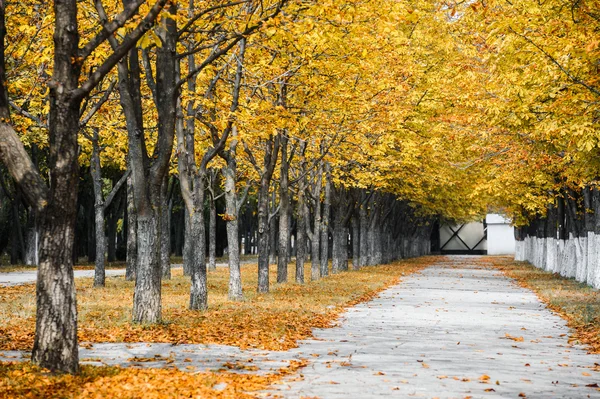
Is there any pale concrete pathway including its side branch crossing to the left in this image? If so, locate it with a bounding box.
[0,257,600,399]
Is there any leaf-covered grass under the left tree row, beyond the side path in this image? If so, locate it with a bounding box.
[0,257,436,350]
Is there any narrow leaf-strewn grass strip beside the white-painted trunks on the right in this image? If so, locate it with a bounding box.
[486,257,600,353]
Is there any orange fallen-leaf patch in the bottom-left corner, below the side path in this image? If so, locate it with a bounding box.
[0,361,306,399]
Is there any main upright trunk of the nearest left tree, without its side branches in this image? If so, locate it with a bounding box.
[31,0,81,373]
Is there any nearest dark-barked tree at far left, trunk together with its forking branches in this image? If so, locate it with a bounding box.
[0,0,166,373]
